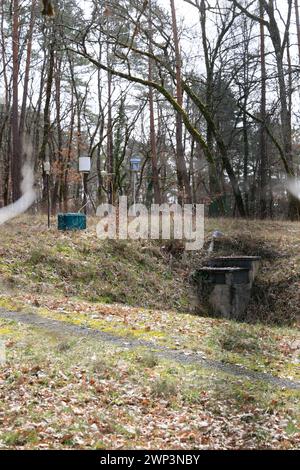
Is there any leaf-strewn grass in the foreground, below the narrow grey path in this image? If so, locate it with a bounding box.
[0,320,300,450]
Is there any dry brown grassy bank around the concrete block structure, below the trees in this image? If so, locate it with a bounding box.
[0,217,300,326]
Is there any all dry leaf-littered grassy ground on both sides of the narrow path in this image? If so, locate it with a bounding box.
[0,218,300,449]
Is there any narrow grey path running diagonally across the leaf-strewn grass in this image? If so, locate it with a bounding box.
[0,308,300,390]
